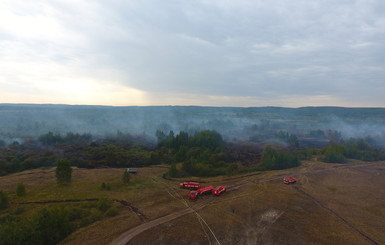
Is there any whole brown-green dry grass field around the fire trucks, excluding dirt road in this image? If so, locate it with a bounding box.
[0,161,385,244]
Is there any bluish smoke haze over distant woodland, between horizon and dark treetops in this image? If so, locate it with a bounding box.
[0,104,385,144]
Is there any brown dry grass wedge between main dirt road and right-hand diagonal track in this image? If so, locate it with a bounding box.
[130,178,364,244]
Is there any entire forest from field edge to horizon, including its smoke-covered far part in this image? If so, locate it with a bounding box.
[0,104,385,177]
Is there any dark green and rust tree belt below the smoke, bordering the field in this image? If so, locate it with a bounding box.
[0,130,385,177]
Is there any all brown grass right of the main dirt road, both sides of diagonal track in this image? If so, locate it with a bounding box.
[124,161,385,244]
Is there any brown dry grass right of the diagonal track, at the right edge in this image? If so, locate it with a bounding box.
[303,162,385,244]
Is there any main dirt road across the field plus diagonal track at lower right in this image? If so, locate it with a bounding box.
[111,162,385,245]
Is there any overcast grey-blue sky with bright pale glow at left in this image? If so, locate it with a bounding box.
[0,0,385,107]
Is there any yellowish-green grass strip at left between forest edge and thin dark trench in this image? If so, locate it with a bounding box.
[0,167,168,201]
